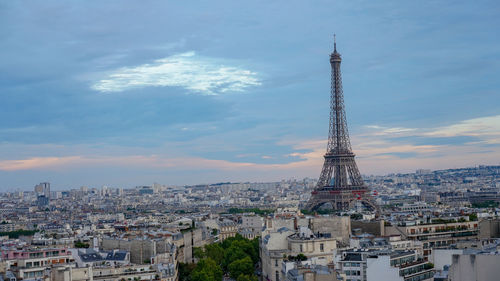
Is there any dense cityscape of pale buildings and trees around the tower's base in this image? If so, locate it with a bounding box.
[0,166,500,281]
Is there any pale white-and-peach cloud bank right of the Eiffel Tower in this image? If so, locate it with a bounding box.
[352,115,500,174]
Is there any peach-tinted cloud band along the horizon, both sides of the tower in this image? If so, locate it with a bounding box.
[0,111,500,178]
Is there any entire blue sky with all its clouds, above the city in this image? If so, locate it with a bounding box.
[0,1,500,190]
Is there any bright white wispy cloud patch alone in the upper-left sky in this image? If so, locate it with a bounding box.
[92,52,261,95]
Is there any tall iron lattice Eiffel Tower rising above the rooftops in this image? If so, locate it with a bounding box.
[306,35,378,212]
